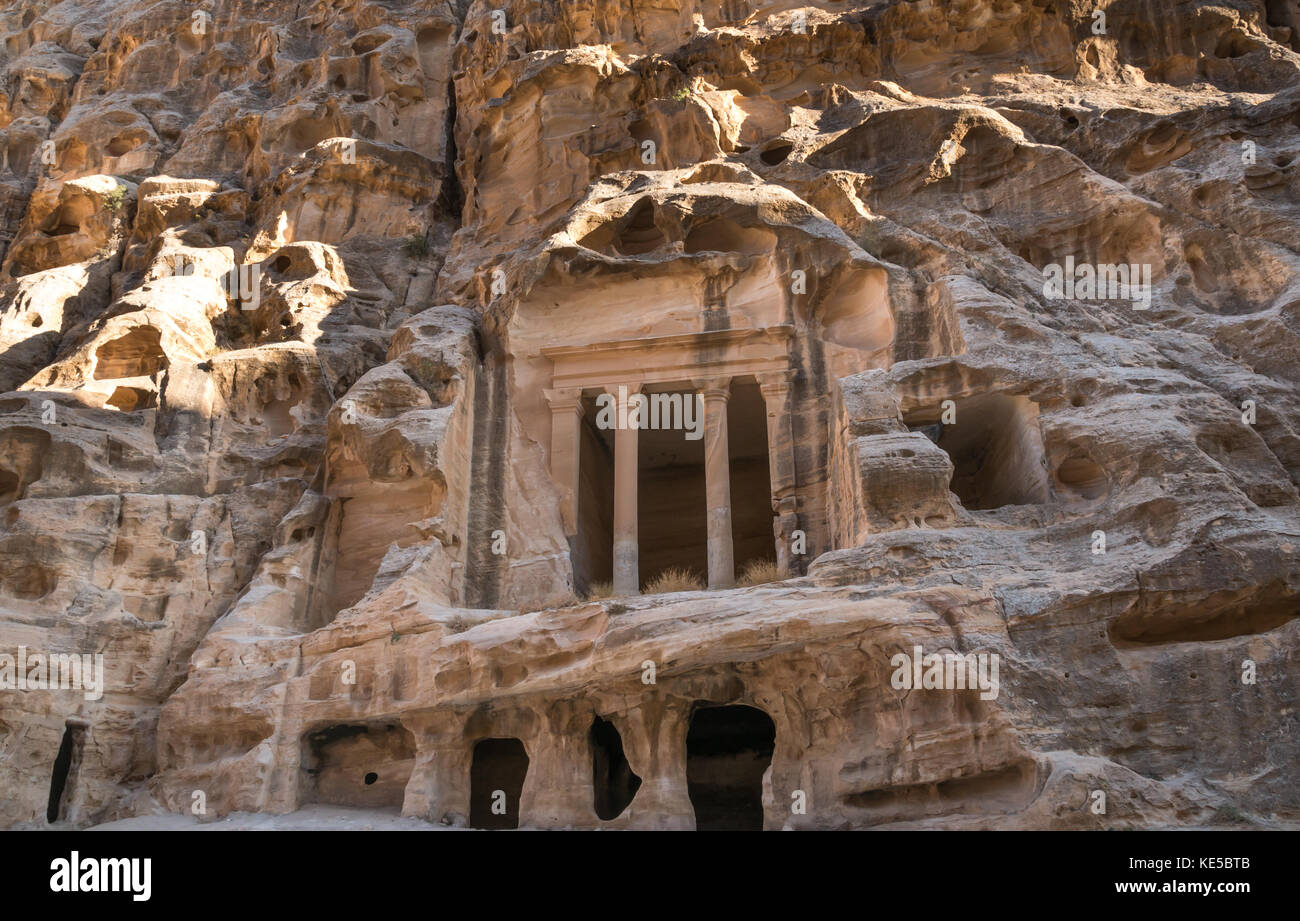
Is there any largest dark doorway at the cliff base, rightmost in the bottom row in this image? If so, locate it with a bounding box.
[686,705,776,831]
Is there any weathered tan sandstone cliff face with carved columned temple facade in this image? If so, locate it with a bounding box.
[0,0,1300,829]
